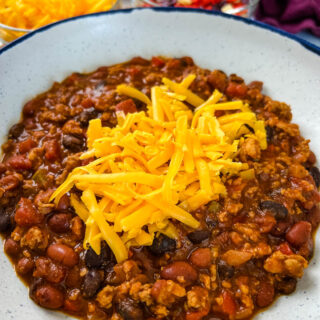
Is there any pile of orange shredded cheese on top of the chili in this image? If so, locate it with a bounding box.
[51,75,267,262]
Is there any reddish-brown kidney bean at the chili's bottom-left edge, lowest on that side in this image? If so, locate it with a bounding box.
[34,284,64,309]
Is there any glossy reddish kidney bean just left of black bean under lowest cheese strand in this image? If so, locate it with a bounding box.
[47,243,79,267]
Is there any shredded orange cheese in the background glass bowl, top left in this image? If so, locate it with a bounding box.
[0,0,115,29]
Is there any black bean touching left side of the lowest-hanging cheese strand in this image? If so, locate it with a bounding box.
[84,242,114,269]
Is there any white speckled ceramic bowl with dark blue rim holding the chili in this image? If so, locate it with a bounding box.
[0,9,320,320]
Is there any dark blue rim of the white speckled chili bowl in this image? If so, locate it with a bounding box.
[0,7,320,56]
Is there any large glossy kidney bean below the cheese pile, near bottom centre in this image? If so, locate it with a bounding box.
[160,261,198,282]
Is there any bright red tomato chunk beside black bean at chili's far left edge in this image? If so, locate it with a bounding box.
[14,198,43,227]
